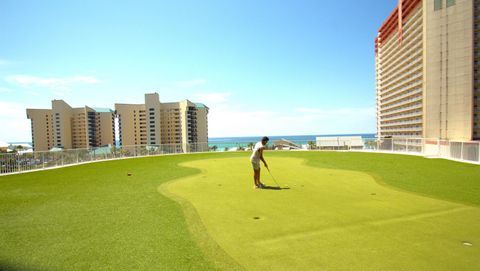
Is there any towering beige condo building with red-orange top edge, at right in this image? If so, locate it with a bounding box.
[375,0,480,141]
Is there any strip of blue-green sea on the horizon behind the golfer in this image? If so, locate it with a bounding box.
[208,134,376,149]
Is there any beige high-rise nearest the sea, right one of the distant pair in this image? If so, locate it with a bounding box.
[115,93,209,149]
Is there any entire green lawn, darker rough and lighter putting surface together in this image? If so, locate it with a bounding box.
[0,152,480,270]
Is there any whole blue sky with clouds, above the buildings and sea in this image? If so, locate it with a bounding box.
[0,0,397,141]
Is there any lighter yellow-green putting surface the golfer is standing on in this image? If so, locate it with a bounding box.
[159,157,480,270]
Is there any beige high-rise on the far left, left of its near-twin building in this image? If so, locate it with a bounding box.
[27,100,115,151]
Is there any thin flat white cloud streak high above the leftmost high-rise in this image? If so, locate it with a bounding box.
[5,75,100,91]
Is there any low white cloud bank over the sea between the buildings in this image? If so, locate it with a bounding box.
[209,104,375,137]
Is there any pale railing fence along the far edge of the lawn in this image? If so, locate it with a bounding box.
[0,138,480,175]
